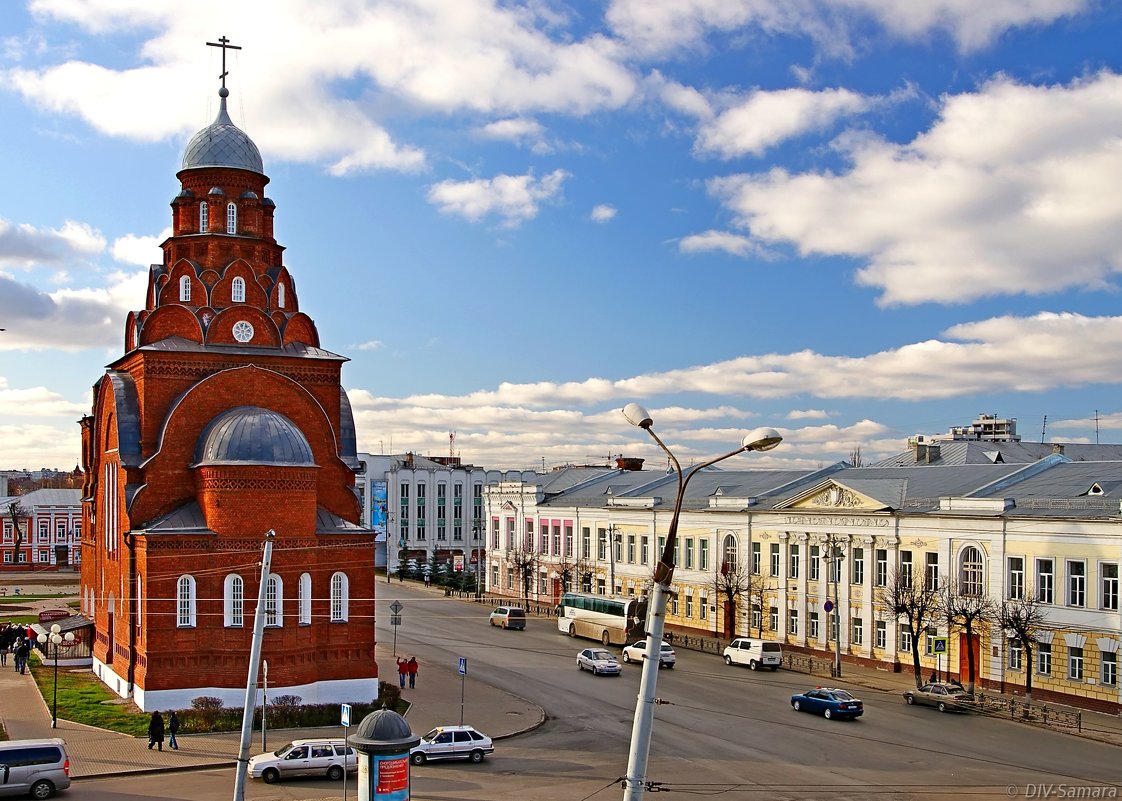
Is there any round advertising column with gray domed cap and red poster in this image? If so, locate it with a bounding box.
[347,708,421,801]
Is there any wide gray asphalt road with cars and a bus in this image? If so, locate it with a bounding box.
[80,584,1122,801]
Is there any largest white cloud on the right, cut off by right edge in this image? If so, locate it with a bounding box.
[710,73,1122,304]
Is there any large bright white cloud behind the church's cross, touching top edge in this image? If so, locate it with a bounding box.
[13,0,637,175]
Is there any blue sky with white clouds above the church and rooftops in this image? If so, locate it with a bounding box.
[0,0,1122,469]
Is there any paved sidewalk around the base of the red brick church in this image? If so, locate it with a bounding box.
[0,646,545,779]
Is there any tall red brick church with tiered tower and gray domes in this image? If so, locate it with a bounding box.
[81,56,378,710]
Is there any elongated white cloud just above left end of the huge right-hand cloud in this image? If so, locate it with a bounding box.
[695,89,870,158]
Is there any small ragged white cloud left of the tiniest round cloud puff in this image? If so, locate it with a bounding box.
[429,169,569,227]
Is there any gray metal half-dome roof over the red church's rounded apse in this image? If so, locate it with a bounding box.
[195,406,315,467]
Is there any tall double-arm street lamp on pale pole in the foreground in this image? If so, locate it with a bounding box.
[623,403,783,801]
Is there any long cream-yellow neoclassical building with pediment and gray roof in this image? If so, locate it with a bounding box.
[484,452,1122,712]
